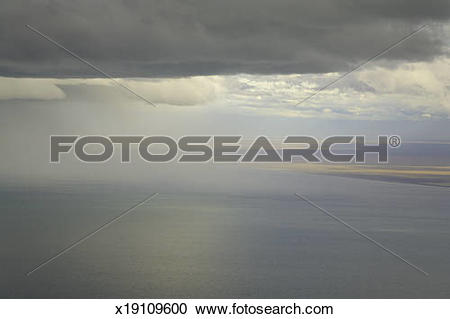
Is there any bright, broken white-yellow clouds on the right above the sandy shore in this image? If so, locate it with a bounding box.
[221,57,450,119]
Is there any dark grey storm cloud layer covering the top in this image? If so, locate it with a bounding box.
[0,0,450,77]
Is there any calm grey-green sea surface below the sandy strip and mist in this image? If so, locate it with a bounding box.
[0,170,450,298]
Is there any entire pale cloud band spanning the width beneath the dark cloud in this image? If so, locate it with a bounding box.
[0,57,450,119]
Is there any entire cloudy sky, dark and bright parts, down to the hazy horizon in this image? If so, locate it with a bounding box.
[0,0,450,181]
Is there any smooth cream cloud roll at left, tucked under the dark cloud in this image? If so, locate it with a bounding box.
[0,76,224,105]
